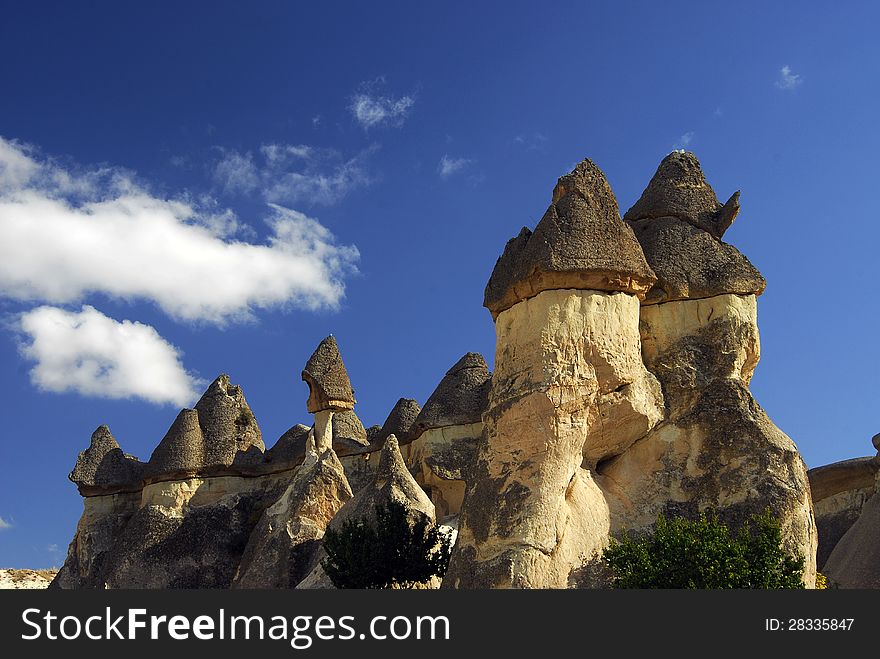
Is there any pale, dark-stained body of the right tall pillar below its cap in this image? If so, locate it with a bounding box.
[598,295,817,585]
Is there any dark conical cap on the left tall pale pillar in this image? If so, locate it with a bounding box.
[483,160,656,318]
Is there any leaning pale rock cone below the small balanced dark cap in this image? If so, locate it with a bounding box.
[232,449,351,588]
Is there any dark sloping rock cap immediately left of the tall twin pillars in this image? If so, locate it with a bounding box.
[410,352,492,440]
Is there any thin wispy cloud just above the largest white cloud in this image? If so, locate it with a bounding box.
[214,144,378,206]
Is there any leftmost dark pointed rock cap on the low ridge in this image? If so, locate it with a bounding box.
[68,426,144,496]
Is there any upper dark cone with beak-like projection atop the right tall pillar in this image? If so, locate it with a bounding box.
[623,151,739,240]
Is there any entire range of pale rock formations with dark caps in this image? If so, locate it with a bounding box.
[53,152,824,588]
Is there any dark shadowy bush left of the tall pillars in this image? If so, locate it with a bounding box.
[321,501,452,588]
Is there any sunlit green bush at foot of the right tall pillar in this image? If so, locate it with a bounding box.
[602,510,804,589]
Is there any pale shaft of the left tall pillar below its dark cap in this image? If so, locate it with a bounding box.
[444,290,663,588]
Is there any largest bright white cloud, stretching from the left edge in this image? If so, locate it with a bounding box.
[0,138,358,323]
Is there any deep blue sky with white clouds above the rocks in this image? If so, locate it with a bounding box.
[0,2,880,567]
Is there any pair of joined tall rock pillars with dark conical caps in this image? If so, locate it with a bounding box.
[444,153,816,588]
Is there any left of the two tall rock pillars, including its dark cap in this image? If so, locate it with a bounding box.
[444,160,663,588]
